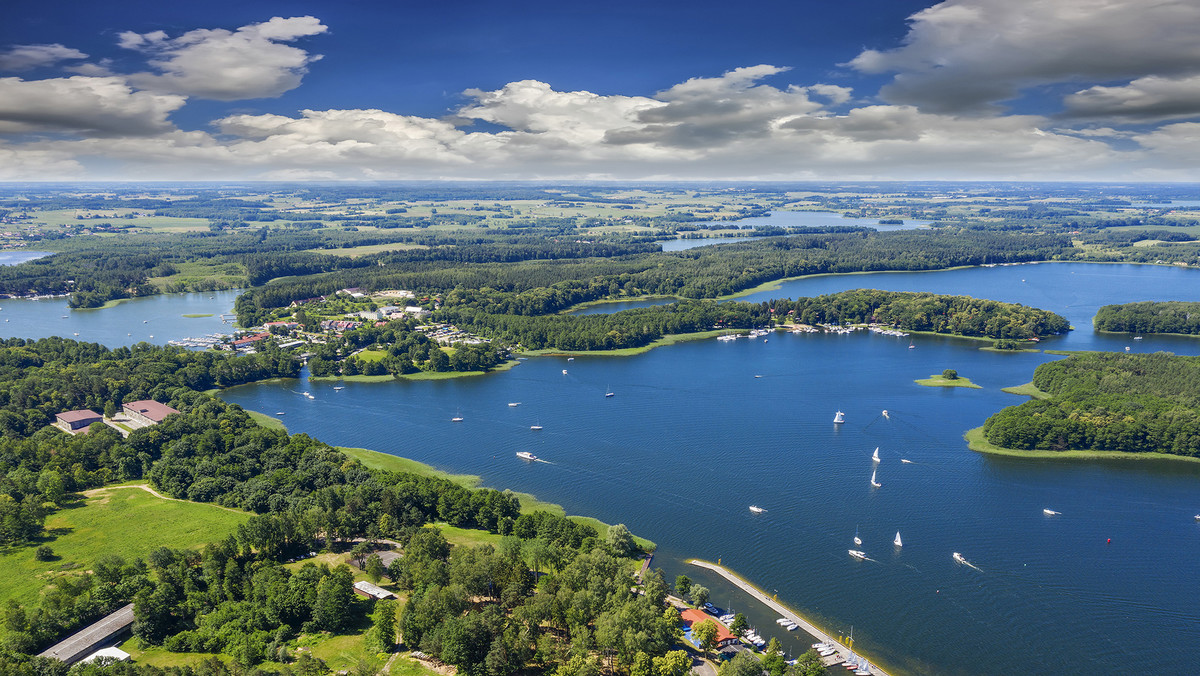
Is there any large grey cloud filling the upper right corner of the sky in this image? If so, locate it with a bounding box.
[848,0,1200,112]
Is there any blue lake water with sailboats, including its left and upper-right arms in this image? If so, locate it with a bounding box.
[0,264,1200,675]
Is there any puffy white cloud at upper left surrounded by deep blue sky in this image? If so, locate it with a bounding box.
[120,17,326,101]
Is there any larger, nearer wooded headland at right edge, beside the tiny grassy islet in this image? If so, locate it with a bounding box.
[984,352,1200,457]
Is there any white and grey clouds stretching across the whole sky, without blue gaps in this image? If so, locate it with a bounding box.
[0,0,1200,180]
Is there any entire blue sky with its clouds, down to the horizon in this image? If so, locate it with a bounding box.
[0,0,1200,181]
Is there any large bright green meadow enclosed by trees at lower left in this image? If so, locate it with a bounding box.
[0,486,251,604]
